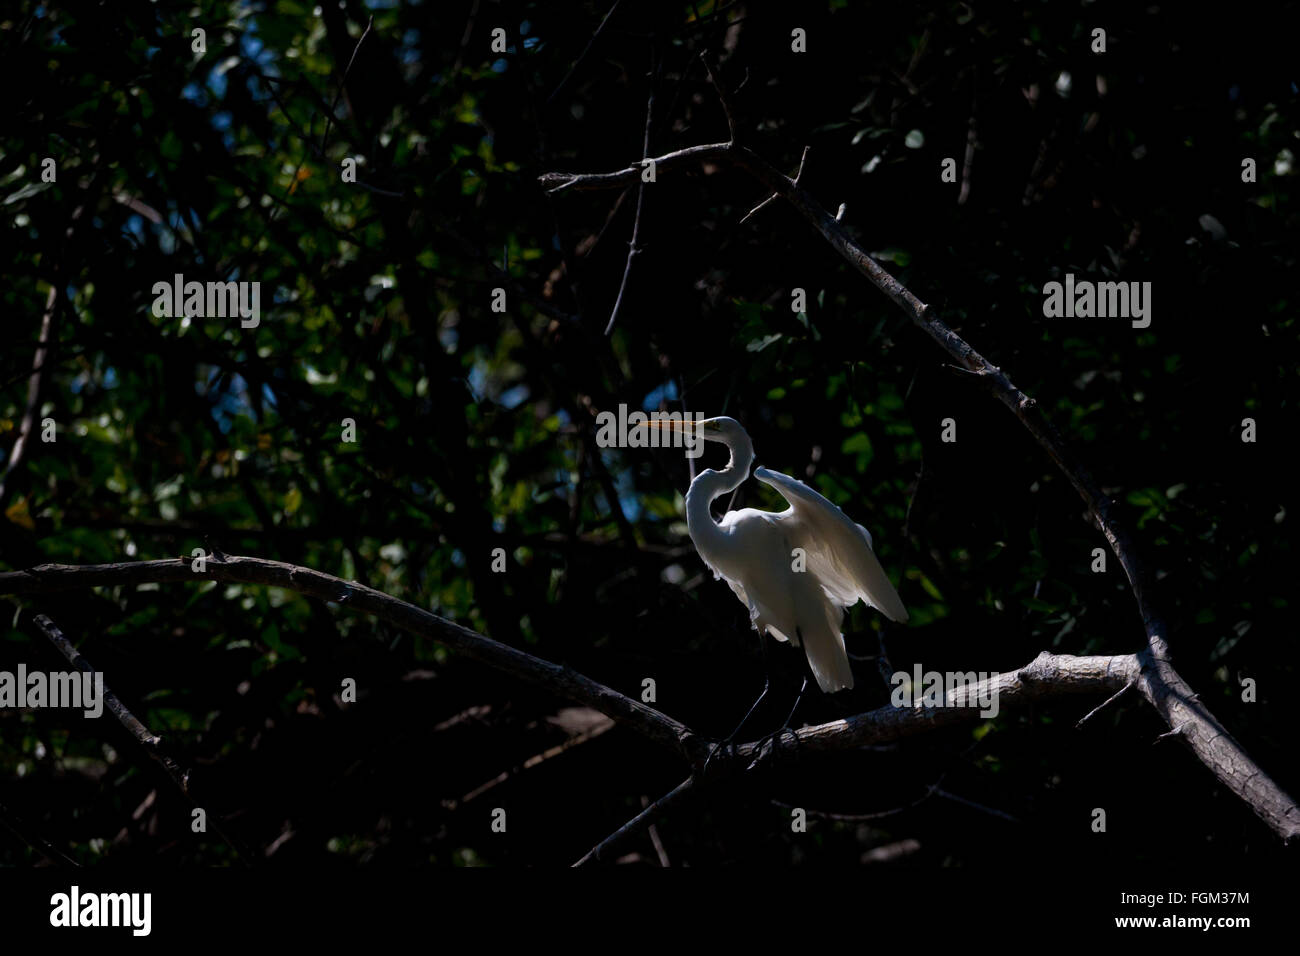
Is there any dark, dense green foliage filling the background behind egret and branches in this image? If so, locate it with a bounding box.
[0,0,1300,866]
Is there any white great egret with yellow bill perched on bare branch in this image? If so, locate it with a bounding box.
[645,418,907,697]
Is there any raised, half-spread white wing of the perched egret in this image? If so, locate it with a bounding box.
[754,468,907,622]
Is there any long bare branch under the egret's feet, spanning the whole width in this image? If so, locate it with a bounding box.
[0,564,1300,852]
